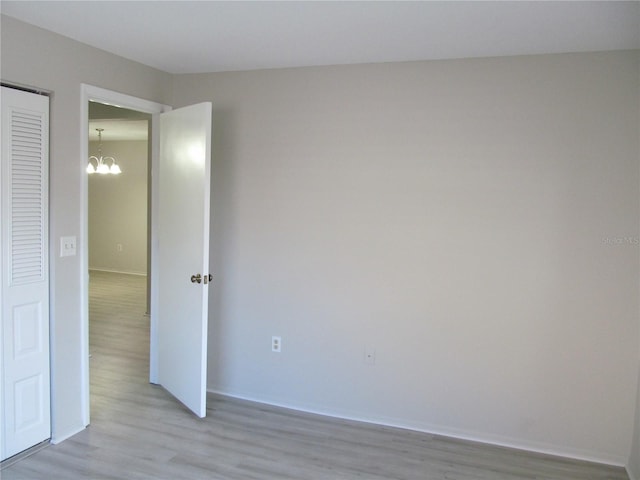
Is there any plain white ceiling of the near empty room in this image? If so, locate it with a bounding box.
[0,0,640,73]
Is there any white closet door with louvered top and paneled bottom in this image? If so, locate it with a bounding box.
[0,87,51,460]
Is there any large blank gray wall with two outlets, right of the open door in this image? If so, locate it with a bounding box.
[174,52,640,464]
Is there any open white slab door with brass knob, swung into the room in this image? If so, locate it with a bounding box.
[157,102,212,417]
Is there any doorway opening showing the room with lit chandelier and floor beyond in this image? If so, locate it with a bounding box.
[87,101,151,415]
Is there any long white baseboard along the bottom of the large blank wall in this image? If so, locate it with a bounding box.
[207,388,624,468]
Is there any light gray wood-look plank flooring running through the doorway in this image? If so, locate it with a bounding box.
[1,272,628,480]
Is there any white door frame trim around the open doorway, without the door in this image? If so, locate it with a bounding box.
[78,83,172,425]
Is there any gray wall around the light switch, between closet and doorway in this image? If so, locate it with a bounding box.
[0,16,171,441]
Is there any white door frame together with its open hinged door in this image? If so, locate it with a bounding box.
[79,85,212,425]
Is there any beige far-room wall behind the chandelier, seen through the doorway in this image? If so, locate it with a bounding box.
[89,140,148,275]
